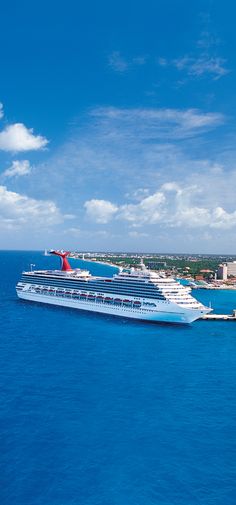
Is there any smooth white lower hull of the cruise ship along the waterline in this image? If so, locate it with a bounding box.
[17,290,209,324]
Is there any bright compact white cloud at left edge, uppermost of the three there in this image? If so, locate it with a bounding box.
[0,123,48,152]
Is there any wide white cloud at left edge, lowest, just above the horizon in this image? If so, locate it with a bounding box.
[0,186,63,229]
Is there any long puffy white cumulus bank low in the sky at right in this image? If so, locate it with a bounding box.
[85,182,236,229]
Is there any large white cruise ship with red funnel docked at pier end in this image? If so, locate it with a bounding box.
[16,251,211,323]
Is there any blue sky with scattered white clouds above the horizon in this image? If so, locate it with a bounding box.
[0,0,236,254]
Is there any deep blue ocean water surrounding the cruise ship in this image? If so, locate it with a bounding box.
[0,252,236,505]
